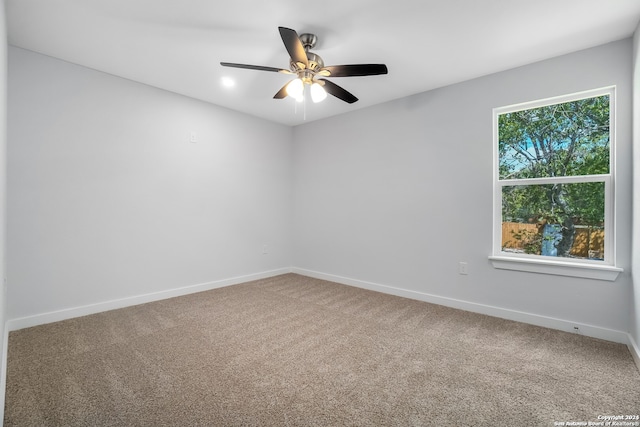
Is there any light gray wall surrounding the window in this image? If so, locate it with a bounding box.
[293,39,632,340]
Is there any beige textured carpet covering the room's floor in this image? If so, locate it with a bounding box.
[4,274,640,426]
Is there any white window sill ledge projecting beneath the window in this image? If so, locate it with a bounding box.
[489,255,624,282]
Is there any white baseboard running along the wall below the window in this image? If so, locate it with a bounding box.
[291,267,640,346]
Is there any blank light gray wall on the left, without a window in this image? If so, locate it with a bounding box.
[7,47,292,319]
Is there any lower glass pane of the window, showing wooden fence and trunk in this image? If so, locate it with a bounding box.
[502,182,605,260]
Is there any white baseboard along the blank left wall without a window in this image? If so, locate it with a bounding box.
[6,268,291,331]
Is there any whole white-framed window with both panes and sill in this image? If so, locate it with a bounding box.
[491,87,621,280]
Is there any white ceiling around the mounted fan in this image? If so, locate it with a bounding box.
[6,0,640,125]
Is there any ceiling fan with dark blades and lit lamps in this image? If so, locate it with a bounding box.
[220,27,387,104]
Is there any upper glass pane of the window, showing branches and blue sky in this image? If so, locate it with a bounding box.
[498,95,609,179]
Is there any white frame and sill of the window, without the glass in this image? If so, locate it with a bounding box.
[489,86,623,281]
